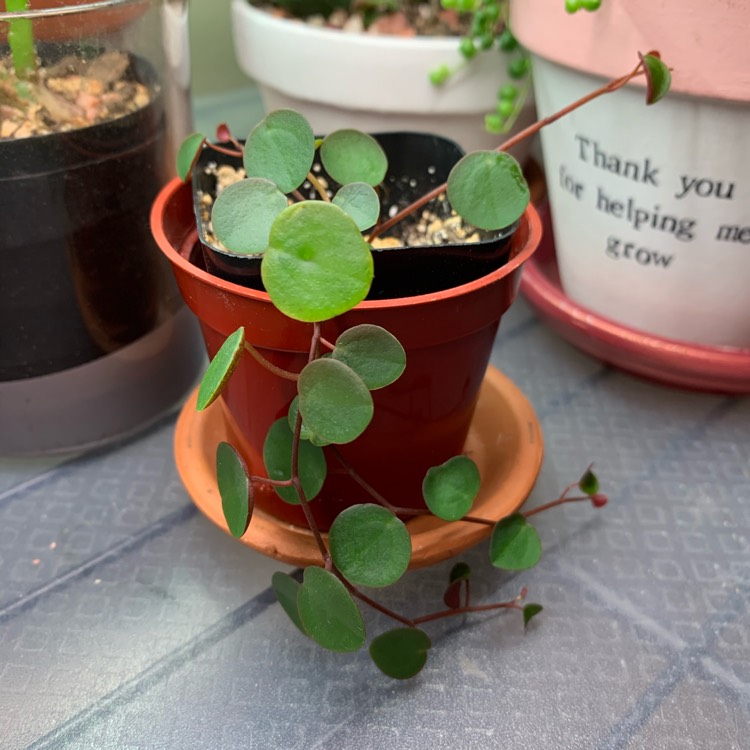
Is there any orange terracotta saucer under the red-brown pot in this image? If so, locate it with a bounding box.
[175,367,543,568]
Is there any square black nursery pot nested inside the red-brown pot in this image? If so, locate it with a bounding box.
[193,133,516,299]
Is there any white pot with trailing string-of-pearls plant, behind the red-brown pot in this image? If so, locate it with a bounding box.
[226,0,534,156]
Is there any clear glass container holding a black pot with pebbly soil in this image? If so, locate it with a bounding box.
[0,0,202,454]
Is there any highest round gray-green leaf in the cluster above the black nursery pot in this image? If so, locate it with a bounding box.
[243,109,315,193]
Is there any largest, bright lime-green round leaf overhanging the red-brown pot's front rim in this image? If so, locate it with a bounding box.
[261,201,373,323]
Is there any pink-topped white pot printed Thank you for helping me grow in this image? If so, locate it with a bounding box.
[512,0,750,348]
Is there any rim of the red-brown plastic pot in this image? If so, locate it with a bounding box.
[151,177,542,310]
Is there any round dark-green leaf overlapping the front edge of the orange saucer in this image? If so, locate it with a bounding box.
[328,503,411,588]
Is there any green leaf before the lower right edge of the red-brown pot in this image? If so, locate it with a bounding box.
[422,456,481,521]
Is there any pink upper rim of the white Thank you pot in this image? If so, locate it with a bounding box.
[511,0,750,102]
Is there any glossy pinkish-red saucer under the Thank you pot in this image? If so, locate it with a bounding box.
[521,210,750,394]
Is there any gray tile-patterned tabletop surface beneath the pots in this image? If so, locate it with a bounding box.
[0,301,750,750]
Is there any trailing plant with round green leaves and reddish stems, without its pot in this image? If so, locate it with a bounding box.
[178,53,670,679]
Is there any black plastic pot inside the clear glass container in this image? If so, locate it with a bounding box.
[0,50,176,381]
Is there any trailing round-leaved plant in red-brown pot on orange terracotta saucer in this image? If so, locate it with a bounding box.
[152,55,668,678]
